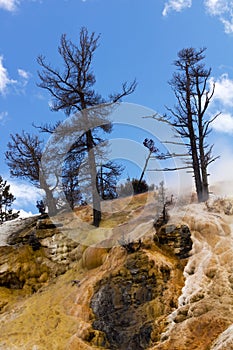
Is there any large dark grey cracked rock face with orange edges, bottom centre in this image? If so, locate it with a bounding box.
[91,252,183,350]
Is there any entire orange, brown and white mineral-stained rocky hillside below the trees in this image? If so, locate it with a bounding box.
[0,196,233,350]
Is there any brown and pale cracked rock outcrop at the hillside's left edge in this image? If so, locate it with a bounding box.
[0,217,78,292]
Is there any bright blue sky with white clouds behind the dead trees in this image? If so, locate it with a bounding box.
[0,0,233,211]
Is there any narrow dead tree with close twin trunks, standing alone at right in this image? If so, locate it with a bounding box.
[159,47,219,202]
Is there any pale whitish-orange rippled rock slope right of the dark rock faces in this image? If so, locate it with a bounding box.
[153,203,233,350]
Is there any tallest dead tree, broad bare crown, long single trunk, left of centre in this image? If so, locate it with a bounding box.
[38,28,136,226]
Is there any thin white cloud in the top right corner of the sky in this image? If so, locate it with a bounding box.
[204,0,233,34]
